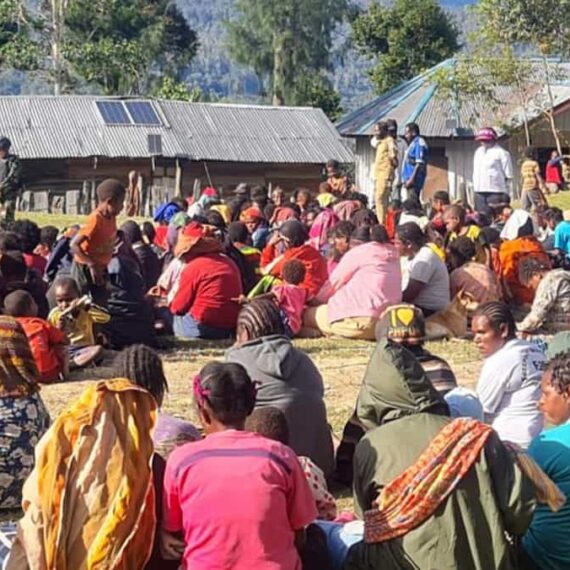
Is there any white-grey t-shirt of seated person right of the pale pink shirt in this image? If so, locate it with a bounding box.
[409,245,449,311]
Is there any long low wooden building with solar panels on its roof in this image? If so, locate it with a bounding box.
[0,95,353,212]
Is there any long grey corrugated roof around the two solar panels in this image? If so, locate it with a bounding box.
[0,96,354,164]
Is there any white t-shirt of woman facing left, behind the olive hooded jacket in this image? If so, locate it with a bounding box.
[477,339,545,449]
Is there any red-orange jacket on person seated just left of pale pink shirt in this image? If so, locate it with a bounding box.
[261,244,328,297]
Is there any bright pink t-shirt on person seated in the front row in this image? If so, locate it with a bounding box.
[163,430,317,570]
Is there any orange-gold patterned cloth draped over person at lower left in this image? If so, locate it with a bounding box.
[7,379,155,570]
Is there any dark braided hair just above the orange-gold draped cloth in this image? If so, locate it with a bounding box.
[113,344,168,404]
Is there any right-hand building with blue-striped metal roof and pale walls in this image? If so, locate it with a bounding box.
[337,59,570,203]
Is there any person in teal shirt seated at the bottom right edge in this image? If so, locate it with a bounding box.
[522,352,570,570]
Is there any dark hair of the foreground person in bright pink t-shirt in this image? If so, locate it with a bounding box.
[199,362,256,426]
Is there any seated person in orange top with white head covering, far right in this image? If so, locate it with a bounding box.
[499,210,550,305]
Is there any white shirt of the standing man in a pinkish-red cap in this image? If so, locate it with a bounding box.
[473,144,513,193]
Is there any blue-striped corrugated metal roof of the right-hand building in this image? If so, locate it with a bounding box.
[337,59,570,138]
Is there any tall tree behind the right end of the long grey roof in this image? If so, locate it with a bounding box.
[227,0,349,109]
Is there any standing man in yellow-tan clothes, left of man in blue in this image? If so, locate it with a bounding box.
[374,121,398,224]
